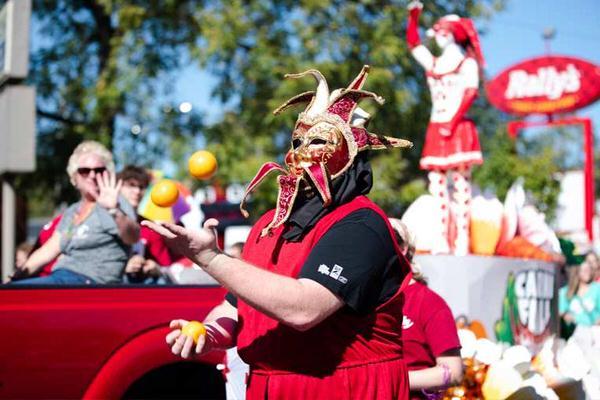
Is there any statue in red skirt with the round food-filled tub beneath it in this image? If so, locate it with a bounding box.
[402,2,560,350]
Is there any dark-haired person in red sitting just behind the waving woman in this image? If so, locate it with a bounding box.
[117,165,174,283]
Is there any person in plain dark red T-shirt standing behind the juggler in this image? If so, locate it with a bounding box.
[390,218,463,399]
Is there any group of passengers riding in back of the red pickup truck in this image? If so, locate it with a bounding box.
[10,141,243,285]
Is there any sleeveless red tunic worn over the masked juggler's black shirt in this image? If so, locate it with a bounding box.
[237,196,410,398]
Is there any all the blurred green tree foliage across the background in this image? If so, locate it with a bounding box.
[20,0,568,225]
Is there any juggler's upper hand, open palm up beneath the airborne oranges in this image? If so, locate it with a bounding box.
[142,218,221,267]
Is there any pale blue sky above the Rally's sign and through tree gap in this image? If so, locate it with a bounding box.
[173,0,600,158]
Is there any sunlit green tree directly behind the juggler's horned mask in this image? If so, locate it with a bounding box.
[186,0,501,219]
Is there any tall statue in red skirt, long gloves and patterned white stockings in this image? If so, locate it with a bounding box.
[406,1,484,255]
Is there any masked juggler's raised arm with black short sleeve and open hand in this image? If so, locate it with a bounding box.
[143,209,402,330]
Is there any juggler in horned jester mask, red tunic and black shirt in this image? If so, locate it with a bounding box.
[143,66,418,400]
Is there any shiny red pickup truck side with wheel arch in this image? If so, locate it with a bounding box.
[0,285,225,399]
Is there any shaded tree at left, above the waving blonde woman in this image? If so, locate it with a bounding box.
[17,0,201,214]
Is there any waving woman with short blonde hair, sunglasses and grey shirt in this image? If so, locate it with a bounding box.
[13,141,139,285]
